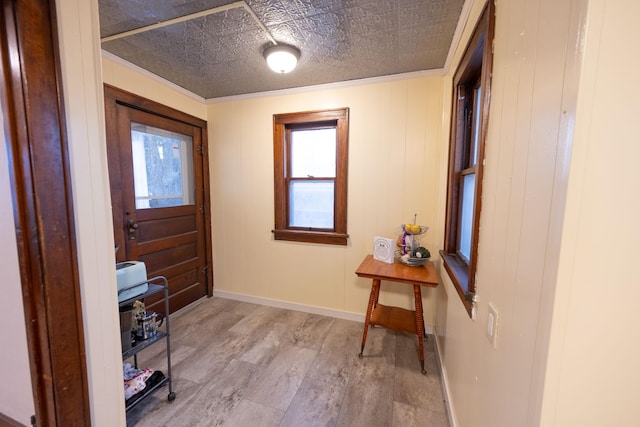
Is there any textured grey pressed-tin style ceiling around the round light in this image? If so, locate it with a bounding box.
[99,0,464,99]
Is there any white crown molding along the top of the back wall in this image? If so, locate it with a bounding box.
[205,68,446,105]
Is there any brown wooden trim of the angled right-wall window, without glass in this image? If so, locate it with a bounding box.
[440,2,495,317]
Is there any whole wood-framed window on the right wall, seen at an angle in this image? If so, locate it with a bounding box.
[441,2,495,317]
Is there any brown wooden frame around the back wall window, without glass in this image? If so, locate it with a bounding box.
[273,108,349,246]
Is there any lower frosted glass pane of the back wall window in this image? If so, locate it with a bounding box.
[289,180,334,229]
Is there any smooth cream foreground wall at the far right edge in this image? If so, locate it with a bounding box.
[542,0,640,426]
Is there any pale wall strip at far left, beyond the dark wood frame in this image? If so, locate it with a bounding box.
[0,103,35,425]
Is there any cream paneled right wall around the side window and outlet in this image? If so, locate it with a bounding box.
[437,0,586,427]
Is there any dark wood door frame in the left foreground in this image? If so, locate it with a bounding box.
[0,0,91,426]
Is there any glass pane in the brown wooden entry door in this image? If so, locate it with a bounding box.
[131,123,195,209]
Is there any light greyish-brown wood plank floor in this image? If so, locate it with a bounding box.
[127,297,449,427]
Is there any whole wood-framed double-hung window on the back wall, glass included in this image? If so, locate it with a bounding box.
[273,108,348,245]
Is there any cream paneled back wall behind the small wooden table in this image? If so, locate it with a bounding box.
[208,76,443,325]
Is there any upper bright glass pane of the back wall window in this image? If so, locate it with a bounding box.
[291,128,336,178]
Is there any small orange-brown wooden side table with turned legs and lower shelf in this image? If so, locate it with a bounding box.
[356,255,438,375]
